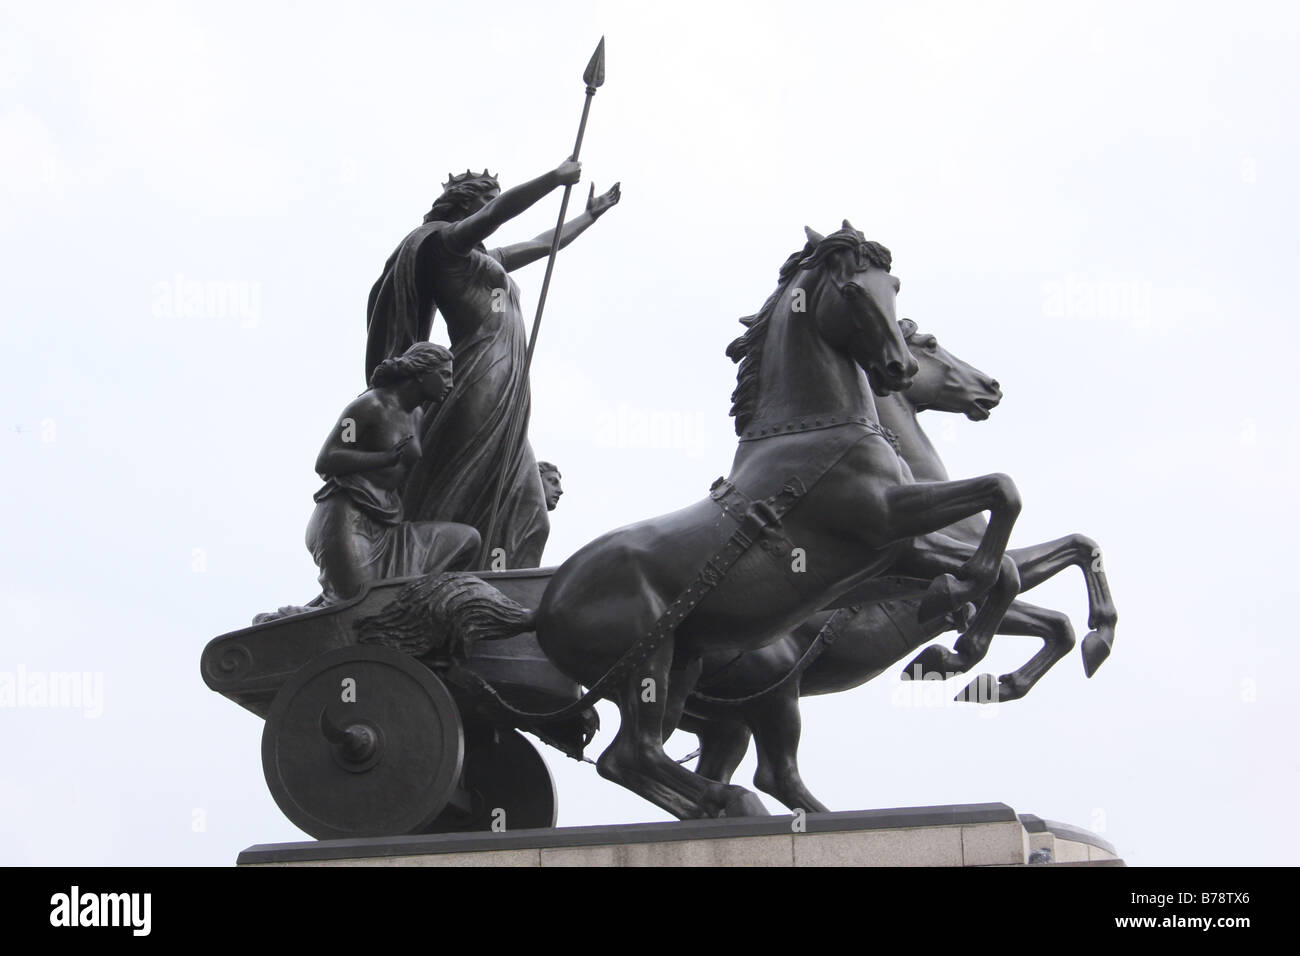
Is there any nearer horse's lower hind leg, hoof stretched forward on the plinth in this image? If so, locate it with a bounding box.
[597,641,767,819]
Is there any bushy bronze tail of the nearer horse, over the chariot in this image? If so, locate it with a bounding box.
[354,572,537,657]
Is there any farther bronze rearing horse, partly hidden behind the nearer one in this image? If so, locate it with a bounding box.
[680,319,1118,812]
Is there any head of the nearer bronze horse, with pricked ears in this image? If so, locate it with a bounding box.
[800,220,918,395]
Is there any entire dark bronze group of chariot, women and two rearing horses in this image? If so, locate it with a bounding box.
[202,40,1115,838]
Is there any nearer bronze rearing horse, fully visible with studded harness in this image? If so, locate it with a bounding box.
[516,221,1021,818]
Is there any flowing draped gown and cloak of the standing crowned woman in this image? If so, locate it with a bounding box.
[365,222,550,568]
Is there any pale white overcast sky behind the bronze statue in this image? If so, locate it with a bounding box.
[0,0,1300,865]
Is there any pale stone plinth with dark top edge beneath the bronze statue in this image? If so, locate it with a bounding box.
[238,804,1123,866]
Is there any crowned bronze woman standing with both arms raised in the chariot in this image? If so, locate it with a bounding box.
[365,163,620,568]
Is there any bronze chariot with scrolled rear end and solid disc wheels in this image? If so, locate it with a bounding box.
[202,568,597,839]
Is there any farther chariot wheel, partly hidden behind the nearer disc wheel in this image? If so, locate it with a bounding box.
[429,727,556,832]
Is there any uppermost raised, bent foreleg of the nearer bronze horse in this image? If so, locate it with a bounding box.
[879,475,1021,621]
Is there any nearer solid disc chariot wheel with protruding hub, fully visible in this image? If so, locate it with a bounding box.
[261,646,464,840]
